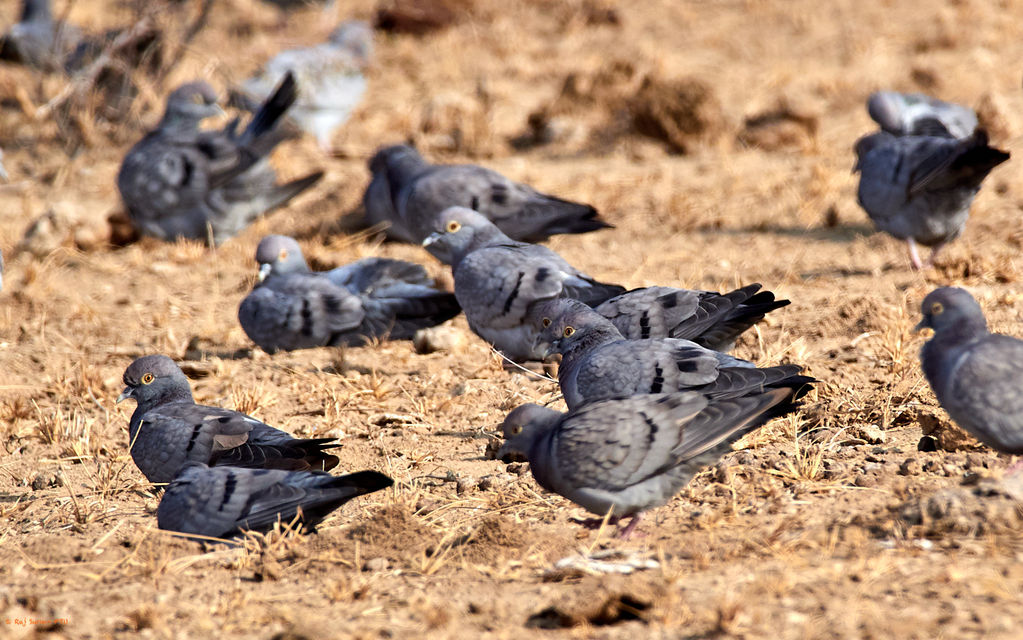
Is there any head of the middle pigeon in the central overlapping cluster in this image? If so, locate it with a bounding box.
[531,298,624,356]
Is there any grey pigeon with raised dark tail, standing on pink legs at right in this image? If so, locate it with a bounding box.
[853,129,1009,269]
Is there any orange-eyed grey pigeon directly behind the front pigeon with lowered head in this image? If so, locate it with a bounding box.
[533,299,814,409]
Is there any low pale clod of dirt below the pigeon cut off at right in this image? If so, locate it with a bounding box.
[899,478,1023,536]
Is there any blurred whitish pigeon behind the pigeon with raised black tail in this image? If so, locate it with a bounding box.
[239,20,373,149]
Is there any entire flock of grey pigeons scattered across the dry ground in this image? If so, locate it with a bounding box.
[1,0,1023,539]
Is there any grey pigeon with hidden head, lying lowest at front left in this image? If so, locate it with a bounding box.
[157,462,394,538]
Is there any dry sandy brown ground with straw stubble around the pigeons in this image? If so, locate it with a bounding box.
[0,0,1023,639]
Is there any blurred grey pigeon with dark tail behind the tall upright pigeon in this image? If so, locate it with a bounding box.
[364,144,611,242]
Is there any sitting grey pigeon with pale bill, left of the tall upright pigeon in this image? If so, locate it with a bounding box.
[238,235,461,353]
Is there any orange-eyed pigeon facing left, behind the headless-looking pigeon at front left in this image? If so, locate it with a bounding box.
[118,356,338,483]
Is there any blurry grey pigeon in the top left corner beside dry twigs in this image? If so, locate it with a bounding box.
[0,0,81,71]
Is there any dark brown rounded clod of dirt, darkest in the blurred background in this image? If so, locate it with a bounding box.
[629,77,724,153]
